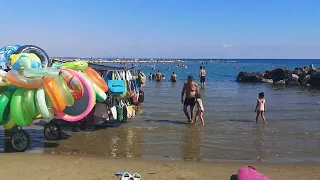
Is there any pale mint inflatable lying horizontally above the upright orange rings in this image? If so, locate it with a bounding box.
[22,68,59,77]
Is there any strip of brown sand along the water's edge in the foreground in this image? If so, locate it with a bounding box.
[0,153,320,180]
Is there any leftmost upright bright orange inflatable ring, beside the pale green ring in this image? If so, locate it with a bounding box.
[43,77,66,111]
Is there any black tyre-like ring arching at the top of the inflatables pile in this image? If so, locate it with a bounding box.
[15,45,52,68]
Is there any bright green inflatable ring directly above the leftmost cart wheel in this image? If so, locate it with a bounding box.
[10,88,35,126]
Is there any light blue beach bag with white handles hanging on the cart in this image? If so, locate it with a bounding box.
[107,71,127,96]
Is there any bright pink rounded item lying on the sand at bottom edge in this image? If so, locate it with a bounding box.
[238,166,270,180]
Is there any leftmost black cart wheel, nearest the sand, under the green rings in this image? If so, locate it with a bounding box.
[11,130,31,152]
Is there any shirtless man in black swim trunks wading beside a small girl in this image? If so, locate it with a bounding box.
[181,76,199,124]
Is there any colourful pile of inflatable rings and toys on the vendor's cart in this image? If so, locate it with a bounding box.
[0,45,145,133]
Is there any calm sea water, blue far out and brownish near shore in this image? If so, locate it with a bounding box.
[0,59,320,163]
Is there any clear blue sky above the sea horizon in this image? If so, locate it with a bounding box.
[0,0,320,58]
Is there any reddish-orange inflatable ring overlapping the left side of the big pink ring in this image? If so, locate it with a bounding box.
[60,70,84,100]
